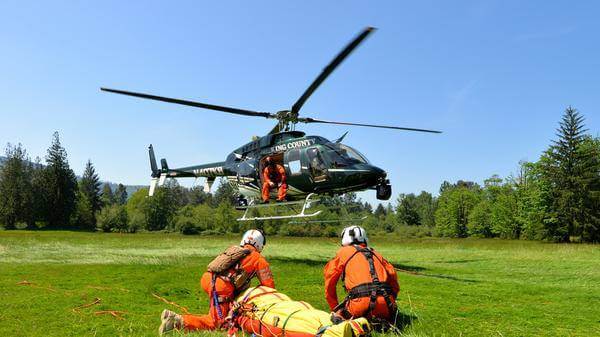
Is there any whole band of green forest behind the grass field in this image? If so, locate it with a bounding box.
[0,107,600,242]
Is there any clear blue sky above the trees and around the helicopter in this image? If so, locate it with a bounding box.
[0,1,600,201]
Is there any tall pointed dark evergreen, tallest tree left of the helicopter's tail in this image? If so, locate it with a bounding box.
[44,132,77,227]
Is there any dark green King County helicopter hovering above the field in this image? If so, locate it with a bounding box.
[100,27,441,221]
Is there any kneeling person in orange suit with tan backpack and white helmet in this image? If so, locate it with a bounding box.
[158,230,275,335]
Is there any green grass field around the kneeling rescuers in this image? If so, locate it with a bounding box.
[0,231,600,336]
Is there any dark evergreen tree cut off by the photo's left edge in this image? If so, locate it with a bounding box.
[0,144,34,229]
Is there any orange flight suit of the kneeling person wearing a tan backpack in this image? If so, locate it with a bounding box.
[182,245,275,330]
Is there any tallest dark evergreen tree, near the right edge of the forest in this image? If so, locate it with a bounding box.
[540,107,598,242]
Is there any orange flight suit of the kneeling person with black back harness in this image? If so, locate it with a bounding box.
[324,245,400,319]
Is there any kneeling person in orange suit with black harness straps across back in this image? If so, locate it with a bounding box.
[325,226,400,322]
